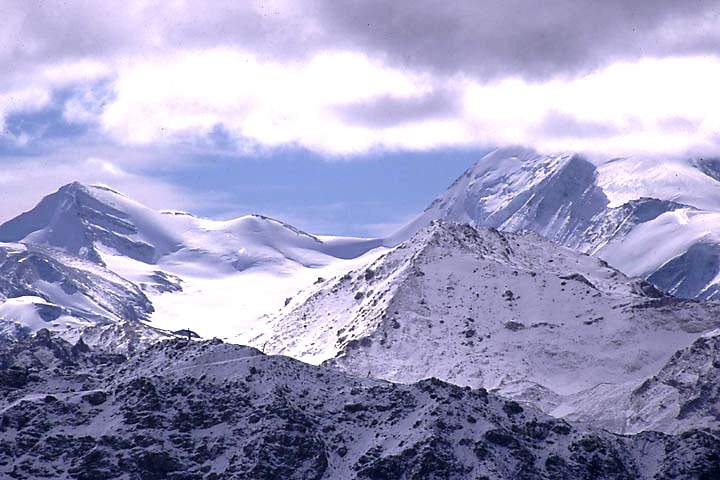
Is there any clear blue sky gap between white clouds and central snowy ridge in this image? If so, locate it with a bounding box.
[157,149,483,235]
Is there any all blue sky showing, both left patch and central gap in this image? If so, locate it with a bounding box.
[0,92,487,236]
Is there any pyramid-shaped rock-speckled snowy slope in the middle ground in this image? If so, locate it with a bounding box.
[255,222,720,432]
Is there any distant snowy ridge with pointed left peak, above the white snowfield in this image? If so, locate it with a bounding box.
[0,183,381,271]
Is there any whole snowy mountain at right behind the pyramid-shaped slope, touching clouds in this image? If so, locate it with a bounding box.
[389,148,720,298]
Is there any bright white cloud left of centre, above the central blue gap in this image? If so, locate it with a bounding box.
[95,49,432,153]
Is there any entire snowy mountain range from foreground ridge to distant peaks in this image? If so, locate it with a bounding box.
[0,148,720,478]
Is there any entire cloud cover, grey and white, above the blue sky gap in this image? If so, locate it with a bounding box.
[0,0,720,161]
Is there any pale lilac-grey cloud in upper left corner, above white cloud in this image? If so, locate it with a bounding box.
[0,0,314,86]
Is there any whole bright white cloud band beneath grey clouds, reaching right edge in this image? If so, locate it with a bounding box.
[80,49,720,155]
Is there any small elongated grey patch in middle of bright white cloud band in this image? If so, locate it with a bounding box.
[337,90,462,127]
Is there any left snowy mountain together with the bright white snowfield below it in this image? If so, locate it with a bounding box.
[0,183,382,344]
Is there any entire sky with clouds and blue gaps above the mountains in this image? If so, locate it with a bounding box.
[0,0,720,235]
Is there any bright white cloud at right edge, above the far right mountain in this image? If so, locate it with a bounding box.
[465,57,720,155]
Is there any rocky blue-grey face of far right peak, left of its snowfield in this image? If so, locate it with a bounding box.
[390,147,608,243]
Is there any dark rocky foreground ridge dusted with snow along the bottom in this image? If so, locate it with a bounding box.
[0,330,720,480]
